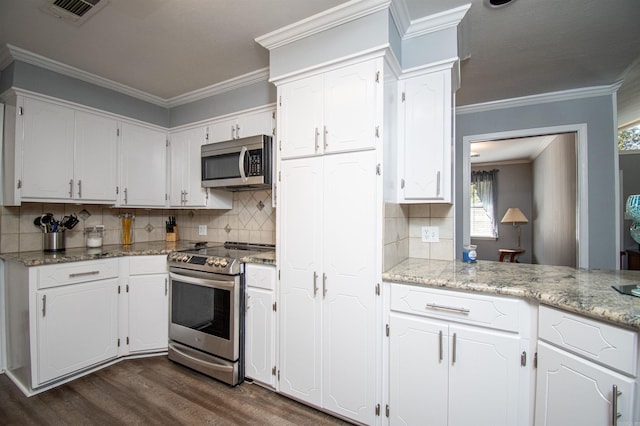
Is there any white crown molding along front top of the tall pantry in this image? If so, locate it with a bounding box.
[255,0,391,50]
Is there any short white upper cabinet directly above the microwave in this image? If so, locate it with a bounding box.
[208,109,274,143]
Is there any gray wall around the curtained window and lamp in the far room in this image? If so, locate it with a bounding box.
[471,163,533,263]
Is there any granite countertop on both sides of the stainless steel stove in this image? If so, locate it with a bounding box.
[0,241,276,266]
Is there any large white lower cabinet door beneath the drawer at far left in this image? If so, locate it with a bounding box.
[33,278,118,387]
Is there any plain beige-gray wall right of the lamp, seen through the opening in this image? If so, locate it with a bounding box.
[529,134,577,267]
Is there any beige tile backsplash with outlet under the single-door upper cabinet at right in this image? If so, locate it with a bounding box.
[383,203,455,270]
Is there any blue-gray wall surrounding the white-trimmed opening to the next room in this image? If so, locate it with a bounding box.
[455,96,619,269]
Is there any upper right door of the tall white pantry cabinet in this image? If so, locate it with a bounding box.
[322,61,381,153]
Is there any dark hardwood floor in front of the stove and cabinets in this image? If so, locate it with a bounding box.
[0,356,348,426]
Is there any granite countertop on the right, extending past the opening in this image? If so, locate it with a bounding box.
[382,258,640,331]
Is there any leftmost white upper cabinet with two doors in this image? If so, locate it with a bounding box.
[15,97,118,203]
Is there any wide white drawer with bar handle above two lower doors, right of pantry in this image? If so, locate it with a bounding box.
[391,284,525,332]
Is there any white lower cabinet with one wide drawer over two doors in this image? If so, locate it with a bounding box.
[388,285,532,426]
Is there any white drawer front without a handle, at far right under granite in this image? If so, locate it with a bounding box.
[538,306,638,376]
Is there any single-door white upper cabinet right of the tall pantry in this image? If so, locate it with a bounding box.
[385,65,453,203]
